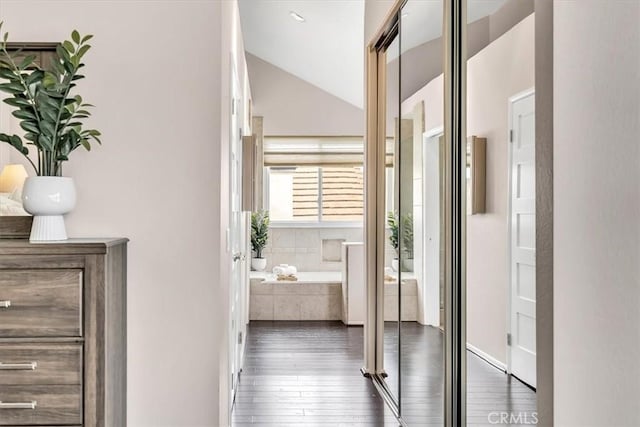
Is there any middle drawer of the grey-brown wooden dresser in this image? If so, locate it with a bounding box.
[0,344,82,387]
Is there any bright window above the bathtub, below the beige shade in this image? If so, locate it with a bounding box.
[266,166,364,224]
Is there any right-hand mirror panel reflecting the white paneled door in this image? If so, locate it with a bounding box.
[466,0,537,424]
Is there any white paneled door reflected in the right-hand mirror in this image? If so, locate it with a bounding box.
[509,92,536,387]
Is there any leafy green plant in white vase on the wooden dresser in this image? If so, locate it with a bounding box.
[0,23,100,241]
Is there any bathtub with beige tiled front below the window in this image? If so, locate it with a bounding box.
[249,271,342,320]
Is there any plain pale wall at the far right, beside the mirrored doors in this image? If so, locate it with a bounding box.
[553,0,640,426]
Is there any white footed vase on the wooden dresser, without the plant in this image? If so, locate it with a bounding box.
[22,176,76,242]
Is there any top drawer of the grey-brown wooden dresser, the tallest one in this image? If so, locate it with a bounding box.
[0,270,82,337]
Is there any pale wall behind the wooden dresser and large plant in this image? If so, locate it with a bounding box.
[0,0,244,427]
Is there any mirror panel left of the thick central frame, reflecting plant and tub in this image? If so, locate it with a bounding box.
[398,0,445,425]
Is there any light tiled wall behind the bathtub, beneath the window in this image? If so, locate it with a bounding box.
[263,225,363,272]
